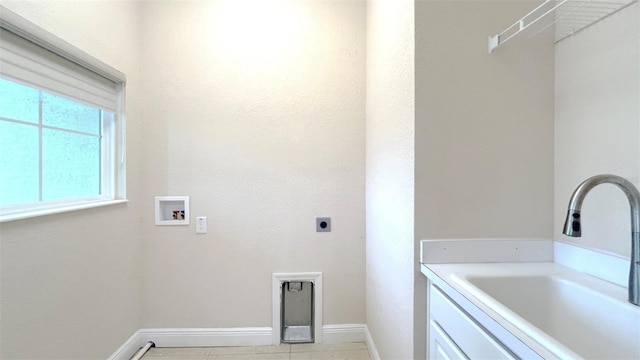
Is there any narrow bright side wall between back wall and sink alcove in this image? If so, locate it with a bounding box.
[366,0,415,359]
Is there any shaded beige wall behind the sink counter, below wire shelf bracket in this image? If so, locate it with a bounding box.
[414,1,554,355]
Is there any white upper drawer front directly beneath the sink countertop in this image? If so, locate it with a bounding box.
[429,285,516,359]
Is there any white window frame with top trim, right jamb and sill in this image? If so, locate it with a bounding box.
[0,5,127,222]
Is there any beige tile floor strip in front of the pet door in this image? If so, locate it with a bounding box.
[142,342,371,360]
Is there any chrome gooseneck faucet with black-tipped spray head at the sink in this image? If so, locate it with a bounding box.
[562,174,640,306]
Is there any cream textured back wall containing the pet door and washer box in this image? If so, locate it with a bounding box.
[140,1,365,327]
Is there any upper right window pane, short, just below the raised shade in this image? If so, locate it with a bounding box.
[42,92,100,134]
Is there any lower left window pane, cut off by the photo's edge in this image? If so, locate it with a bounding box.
[0,121,39,205]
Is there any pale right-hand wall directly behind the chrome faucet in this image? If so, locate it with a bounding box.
[554,4,640,257]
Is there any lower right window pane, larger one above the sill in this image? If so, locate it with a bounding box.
[42,129,100,201]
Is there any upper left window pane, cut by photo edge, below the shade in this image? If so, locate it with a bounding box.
[0,79,39,124]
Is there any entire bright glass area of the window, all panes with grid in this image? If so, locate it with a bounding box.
[0,79,113,206]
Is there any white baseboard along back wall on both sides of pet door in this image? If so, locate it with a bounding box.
[109,324,364,360]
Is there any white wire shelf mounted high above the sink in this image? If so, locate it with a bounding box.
[489,0,638,54]
